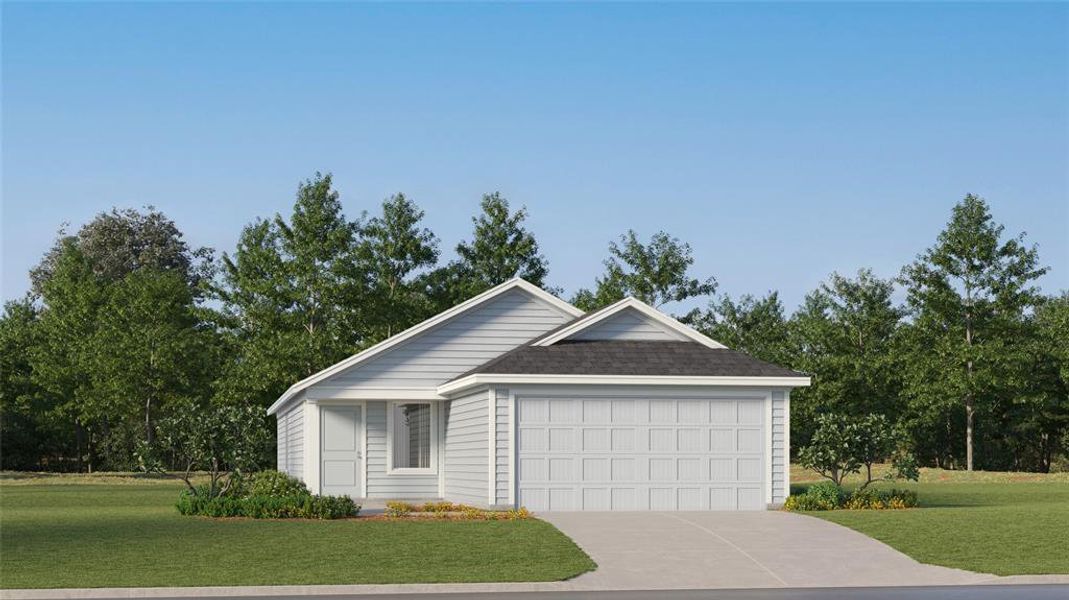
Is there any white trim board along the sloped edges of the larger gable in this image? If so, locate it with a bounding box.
[267,277,583,415]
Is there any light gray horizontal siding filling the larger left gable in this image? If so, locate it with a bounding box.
[319,290,571,389]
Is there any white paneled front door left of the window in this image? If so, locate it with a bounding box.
[320,406,363,497]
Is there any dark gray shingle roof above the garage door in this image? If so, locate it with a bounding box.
[456,340,802,379]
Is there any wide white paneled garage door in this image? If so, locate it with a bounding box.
[516,397,766,511]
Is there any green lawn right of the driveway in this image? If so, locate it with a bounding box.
[791,468,1069,575]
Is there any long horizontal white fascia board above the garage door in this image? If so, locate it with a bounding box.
[438,373,811,397]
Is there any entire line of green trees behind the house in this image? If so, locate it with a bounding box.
[0,173,1069,471]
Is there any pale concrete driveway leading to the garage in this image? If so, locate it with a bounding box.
[539,511,993,589]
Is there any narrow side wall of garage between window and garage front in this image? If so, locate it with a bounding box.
[444,389,490,506]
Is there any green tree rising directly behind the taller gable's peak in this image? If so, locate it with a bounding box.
[440,191,548,309]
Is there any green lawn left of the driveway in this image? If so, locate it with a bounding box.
[0,475,595,588]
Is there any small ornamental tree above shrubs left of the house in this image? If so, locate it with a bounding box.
[139,401,268,498]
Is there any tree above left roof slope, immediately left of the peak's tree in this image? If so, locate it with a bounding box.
[359,194,438,341]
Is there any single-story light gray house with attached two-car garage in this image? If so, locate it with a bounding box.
[268,279,809,511]
